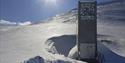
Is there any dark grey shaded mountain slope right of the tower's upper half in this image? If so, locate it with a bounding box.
[97,0,125,25]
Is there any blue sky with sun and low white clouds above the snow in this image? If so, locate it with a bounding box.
[0,0,112,22]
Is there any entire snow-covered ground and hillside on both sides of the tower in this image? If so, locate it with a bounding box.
[0,2,125,63]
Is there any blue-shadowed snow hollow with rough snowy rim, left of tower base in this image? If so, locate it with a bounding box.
[23,35,86,63]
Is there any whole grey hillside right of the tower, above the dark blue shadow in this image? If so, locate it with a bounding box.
[97,0,125,57]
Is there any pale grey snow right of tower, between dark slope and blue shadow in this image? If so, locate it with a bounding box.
[97,23,125,57]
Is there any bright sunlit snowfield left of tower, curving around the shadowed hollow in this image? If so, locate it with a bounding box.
[0,23,84,63]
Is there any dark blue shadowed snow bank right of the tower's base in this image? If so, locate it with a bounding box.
[98,41,125,63]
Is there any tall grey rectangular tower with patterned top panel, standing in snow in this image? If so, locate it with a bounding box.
[77,1,97,61]
